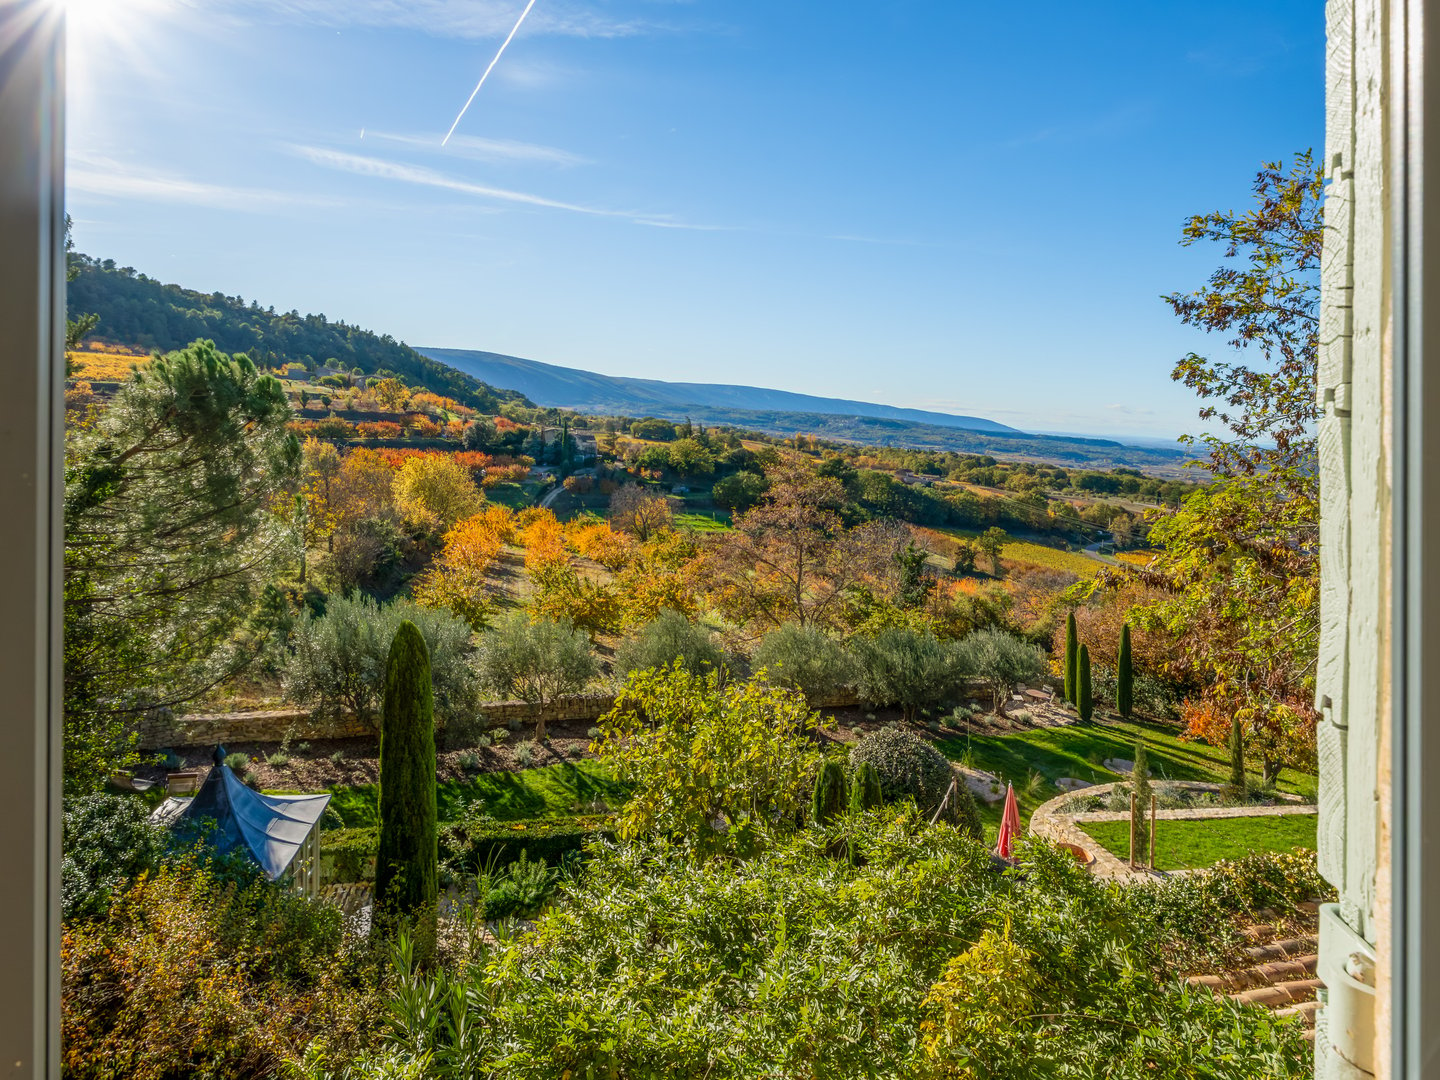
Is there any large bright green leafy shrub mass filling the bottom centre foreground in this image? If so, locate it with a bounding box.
[329,812,1310,1080]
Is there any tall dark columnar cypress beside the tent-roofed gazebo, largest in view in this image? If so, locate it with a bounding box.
[374,621,439,955]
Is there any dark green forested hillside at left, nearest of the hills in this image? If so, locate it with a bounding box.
[69,255,528,413]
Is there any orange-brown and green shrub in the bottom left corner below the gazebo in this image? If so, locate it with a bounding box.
[60,864,382,1080]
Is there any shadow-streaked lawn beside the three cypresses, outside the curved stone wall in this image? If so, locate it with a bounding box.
[936,720,1316,832]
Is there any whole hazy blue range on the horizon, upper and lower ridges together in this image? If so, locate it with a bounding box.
[420,346,1191,472]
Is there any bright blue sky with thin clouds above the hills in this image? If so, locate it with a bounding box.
[66,0,1325,438]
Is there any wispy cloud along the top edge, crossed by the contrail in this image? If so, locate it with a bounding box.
[220,0,667,39]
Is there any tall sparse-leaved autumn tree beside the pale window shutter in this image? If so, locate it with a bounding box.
[1136,151,1323,779]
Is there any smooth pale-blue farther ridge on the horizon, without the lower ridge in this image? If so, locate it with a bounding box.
[419,347,1020,435]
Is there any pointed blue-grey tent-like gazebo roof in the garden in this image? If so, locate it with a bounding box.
[151,765,330,881]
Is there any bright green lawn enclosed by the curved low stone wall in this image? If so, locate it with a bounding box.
[1080,814,1318,870]
